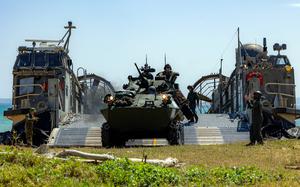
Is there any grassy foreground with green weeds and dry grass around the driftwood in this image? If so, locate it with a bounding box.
[0,140,300,186]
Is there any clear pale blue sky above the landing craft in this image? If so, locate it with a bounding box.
[0,0,300,98]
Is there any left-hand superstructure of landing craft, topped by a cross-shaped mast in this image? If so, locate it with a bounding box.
[0,22,114,145]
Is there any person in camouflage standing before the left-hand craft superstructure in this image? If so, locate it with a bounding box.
[25,108,38,146]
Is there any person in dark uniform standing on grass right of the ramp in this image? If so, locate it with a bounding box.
[247,91,264,146]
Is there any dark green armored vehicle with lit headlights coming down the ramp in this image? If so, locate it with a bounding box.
[101,63,190,147]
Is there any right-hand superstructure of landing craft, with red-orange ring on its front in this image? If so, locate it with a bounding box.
[194,28,300,138]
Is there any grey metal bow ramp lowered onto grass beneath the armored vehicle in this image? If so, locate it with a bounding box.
[48,114,249,147]
